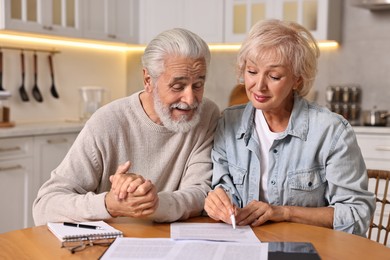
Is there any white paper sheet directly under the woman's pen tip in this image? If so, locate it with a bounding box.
[171,223,260,243]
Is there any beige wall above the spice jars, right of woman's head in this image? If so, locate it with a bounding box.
[316,1,390,110]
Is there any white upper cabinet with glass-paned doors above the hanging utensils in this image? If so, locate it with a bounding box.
[0,0,81,37]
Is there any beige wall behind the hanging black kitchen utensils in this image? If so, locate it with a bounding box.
[0,40,127,124]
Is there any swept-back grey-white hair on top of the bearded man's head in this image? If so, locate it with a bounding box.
[142,28,211,80]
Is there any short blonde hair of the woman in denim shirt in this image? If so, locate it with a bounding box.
[237,19,320,97]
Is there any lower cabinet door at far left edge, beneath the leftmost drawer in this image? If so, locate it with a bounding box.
[0,158,34,233]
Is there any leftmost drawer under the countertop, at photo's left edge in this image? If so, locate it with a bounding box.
[0,137,34,160]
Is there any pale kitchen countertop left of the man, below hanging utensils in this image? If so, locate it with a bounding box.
[0,121,84,138]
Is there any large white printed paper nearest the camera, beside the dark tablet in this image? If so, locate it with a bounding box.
[100,237,268,260]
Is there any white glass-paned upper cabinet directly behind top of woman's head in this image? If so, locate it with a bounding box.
[225,0,342,42]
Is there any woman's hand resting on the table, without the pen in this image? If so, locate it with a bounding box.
[236,201,284,226]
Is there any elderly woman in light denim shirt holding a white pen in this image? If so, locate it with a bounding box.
[205,20,375,236]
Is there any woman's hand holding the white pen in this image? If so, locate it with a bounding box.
[204,188,236,224]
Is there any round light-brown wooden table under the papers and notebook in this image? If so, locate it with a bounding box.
[0,217,390,260]
